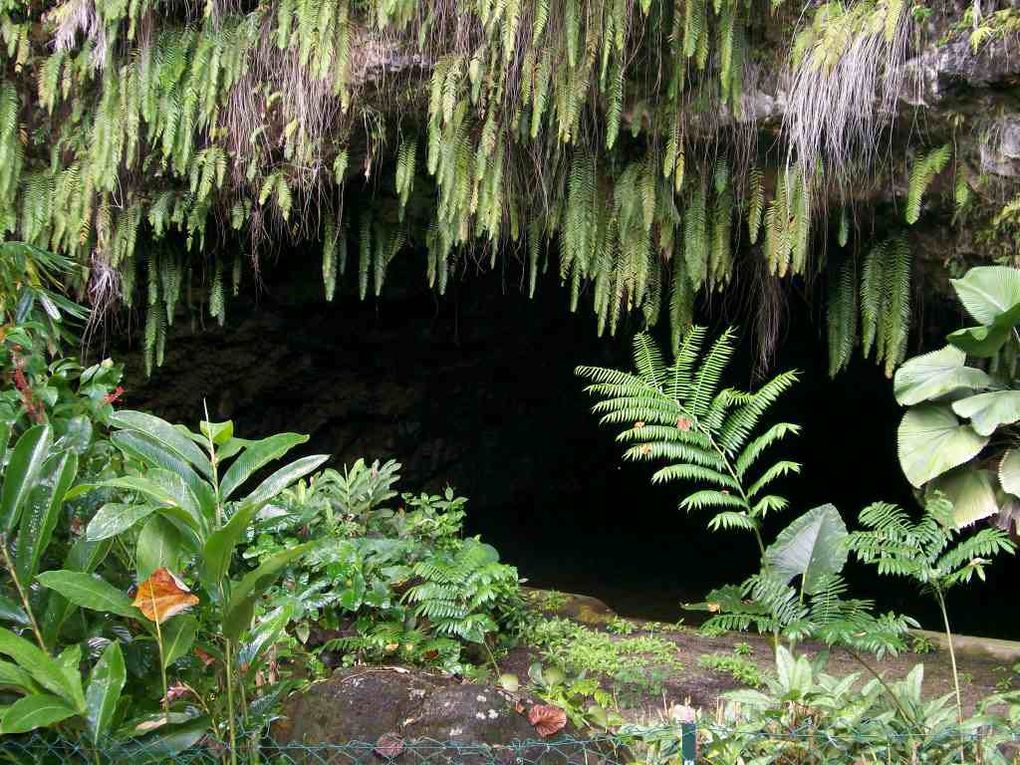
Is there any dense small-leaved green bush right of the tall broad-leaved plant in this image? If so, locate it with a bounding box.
[252,460,521,672]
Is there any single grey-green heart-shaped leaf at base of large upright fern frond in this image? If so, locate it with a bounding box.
[765,505,850,595]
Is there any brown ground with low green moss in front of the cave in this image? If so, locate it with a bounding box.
[510,591,1020,721]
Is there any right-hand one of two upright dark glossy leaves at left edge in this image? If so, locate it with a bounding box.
[14,452,78,581]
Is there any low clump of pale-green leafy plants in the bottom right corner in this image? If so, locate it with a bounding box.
[699,647,1016,765]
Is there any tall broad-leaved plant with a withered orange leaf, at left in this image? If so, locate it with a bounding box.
[40,411,326,759]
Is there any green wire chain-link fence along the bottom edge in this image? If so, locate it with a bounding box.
[0,722,1020,765]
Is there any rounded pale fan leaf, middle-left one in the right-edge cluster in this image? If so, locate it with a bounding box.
[898,404,988,488]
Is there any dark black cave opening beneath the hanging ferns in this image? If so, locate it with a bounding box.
[124,252,1020,638]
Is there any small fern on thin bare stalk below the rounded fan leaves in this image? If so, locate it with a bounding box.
[850,497,1016,722]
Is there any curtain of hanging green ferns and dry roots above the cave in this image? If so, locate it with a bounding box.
[0,0,1005,379]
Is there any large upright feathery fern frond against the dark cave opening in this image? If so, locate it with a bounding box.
[577,326,800,551]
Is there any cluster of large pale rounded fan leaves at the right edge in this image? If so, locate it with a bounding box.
[895,266,1020,527]
